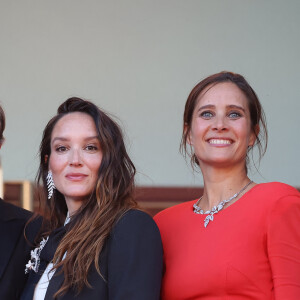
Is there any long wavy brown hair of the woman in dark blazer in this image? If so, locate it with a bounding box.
[36,97,137,296]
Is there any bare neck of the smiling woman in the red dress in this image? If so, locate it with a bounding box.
[200,166,251,210]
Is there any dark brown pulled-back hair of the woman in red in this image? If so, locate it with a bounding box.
[180,71,268,169]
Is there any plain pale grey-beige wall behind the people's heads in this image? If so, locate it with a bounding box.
[0,0,300,186]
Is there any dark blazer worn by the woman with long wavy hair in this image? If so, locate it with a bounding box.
[21,210,163,300]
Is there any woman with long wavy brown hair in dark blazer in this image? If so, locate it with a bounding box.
[21,98,163,300]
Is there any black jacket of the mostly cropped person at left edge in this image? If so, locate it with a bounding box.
[0,199,31,300]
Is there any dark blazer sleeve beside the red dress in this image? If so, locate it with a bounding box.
[107,210,163,300]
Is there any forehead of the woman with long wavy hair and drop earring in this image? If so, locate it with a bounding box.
[51,112,97,140]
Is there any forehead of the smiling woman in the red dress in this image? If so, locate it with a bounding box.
[196,82,248,108]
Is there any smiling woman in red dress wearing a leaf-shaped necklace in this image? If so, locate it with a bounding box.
[154,72,300,300]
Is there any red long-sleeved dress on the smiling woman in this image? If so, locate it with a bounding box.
[154,182,300,300]
